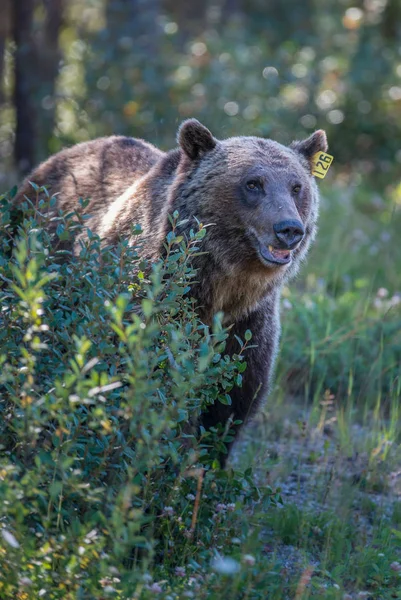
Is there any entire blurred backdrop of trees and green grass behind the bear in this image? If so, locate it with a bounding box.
[0,0,401,405]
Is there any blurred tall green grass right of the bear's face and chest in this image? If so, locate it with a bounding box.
[276,188,401,410]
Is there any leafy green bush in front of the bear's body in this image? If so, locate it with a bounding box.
[0,190,276,599]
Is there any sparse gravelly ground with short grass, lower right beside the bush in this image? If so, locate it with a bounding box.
[233,399,401,600]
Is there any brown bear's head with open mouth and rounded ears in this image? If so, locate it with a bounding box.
[172,119,327,322]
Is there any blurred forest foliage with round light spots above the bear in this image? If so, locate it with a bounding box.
[0,0,401,186]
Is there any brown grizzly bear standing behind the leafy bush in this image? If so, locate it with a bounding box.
[16,119,327,452]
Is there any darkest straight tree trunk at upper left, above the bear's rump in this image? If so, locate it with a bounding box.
[12,0,37,175]
